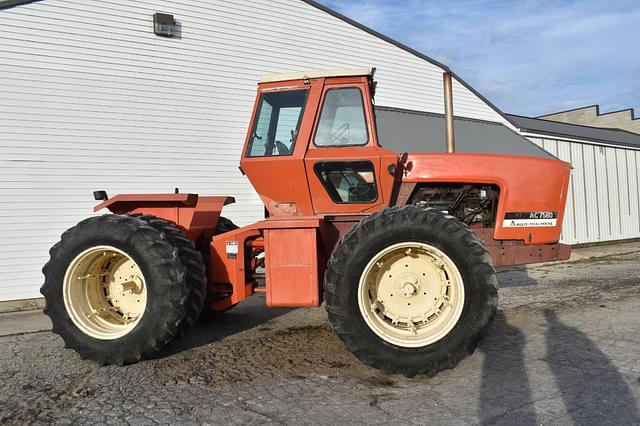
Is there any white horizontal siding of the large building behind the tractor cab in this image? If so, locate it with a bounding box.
[0,0,504,300]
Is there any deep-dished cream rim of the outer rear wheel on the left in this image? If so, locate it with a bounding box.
[63,246,147,340]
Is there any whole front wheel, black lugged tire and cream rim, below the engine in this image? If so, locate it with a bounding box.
[325,206,498,377]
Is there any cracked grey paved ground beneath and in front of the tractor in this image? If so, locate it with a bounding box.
[0,252,640,425]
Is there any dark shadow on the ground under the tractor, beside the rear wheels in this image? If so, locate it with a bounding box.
[153,294,294,359]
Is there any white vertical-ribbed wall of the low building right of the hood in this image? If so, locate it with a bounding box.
[525,134,640,244]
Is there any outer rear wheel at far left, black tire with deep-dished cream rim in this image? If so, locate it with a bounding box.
[40,215,188,365]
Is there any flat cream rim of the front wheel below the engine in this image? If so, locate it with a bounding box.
[358,242,464,348]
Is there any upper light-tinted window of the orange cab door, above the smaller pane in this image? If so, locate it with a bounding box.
[314,87,369,146]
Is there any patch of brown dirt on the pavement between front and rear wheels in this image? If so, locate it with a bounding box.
[156,324,384,385]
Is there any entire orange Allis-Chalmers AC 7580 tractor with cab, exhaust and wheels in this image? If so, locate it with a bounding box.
[42,69,570,376]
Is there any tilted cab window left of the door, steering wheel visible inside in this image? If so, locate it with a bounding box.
[247,90,307,157]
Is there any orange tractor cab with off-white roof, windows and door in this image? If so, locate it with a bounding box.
[240,68,398,216]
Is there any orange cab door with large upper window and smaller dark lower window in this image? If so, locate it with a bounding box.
[305,78,398,214]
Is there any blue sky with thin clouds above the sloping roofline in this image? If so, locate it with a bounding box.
[321,0,640,117]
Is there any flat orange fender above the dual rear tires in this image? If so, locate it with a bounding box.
[93,194,235,241]
